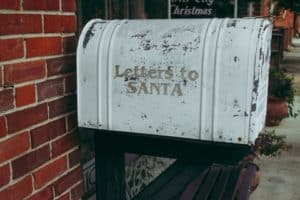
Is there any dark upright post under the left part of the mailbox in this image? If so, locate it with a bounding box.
[95,133,125,200]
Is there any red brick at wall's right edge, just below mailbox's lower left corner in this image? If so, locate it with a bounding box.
[52,132,79,157]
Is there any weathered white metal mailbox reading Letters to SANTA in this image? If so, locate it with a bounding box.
[77,18,272,144]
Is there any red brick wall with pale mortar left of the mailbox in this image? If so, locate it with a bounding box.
[0,0,83,200]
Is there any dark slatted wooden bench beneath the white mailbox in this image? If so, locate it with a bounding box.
[134,161,256,200]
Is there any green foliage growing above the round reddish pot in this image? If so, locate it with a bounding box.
[269,68,297,117]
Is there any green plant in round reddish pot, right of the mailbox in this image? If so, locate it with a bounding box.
[266,68,297,126]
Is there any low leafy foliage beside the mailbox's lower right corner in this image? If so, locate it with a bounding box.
[253,130,291,157]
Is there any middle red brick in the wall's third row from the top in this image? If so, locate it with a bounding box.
[26,37,62,58]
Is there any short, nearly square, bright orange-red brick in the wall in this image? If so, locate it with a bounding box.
[16,84,35,107]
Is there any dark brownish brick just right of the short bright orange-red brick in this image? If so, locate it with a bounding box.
[37,78,64,101]
